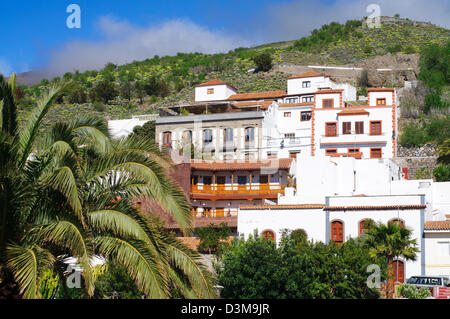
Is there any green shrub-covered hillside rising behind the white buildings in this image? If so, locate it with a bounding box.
[7,17,450,144]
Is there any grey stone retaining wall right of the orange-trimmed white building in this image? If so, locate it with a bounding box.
[394,144,437,179]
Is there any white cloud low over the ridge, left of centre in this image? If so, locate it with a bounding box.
[46,17,250,74]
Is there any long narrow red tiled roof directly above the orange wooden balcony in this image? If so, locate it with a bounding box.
[191,158,293,171]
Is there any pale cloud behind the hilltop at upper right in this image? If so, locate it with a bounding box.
[254,0,450,42]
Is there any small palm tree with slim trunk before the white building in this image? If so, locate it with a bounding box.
[365,223,419,298]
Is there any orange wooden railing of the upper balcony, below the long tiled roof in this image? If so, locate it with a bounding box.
[191,184,286,195]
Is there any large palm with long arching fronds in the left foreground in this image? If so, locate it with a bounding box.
[0,76,214,298]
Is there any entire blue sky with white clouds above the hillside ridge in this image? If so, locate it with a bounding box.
[0,0,450,75]
